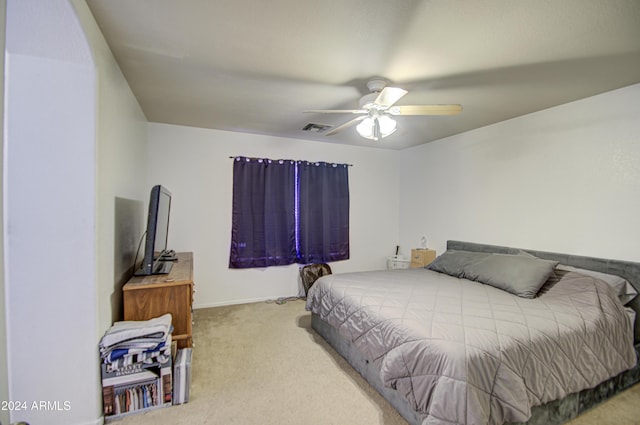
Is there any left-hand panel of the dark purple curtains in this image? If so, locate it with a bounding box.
[229,157,296,268]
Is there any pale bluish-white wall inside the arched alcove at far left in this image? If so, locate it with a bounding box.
[4,0,100,425]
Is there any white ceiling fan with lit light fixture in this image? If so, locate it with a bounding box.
[304,78,462,140]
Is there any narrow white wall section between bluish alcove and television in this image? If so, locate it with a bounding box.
[74,0,148,335]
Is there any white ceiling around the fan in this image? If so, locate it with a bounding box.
[87,0,640,149]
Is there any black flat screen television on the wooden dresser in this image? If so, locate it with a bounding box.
[134,185,175,276]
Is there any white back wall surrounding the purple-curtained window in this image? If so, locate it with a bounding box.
[148,124,399,308]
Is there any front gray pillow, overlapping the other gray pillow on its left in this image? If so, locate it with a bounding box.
[465,254,558,298]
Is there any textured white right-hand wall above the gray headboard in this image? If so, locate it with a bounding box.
[400,85,640,261]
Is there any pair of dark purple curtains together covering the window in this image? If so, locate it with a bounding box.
[229,157,349,268]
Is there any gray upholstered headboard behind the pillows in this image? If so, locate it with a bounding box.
[447,241,640,344]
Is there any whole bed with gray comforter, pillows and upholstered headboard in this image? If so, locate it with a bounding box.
[307,241,640,425]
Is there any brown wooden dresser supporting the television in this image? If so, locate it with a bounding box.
[122,252,194,348]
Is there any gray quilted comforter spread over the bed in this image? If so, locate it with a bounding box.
[307,269,636,425]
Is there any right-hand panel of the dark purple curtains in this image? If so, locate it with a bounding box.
[298,161,349,264]
